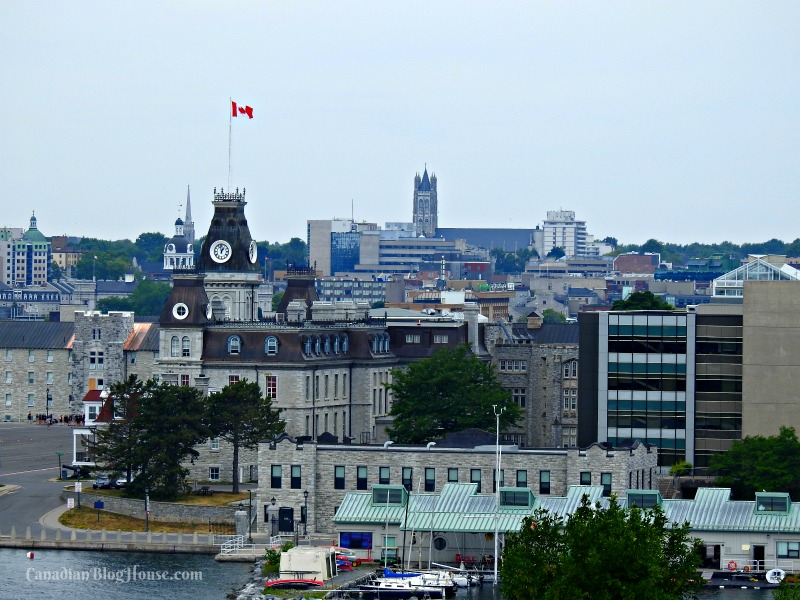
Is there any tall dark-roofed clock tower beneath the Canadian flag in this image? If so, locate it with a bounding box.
[197,188,261,321]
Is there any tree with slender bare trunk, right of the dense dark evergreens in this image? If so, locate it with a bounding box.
[206,379,286,493]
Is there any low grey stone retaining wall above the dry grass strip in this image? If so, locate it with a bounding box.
[61,490,237,525]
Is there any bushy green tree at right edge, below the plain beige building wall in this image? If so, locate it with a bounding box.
[709,427,800,500]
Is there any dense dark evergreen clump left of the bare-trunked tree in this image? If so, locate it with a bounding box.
[90,375,209,500]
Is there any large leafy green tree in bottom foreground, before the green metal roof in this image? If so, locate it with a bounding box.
[500,496,703,600]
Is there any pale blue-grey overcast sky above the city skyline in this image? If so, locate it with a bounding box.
[0,0,800,243]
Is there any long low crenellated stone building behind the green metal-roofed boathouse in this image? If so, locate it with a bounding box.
[256,430,658,533]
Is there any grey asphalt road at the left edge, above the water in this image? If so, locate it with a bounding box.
[0,423,72,535]
